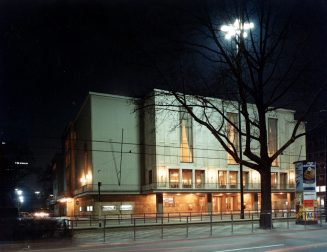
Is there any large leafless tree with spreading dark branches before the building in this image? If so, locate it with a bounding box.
[138,0,326,228]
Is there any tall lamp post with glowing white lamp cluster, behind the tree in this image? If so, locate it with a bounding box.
[221,19,254,219]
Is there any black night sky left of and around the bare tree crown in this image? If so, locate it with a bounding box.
[0,0,327,171]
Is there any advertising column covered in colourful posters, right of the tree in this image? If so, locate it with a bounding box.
[295,161,317,224]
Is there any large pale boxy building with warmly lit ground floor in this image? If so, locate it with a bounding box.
[55,90,306,215]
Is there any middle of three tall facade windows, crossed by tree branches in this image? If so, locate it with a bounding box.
[227,113,240,164]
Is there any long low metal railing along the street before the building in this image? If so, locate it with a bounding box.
[67,210,325,242]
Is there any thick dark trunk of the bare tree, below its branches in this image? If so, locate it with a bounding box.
[260,165,272,229]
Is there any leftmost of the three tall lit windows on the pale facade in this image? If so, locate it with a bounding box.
[179,108,193,163]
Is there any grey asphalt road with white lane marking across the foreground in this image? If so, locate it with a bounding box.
[0,228,327,252]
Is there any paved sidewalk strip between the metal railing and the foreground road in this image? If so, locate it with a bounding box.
[0,220,327,251]
